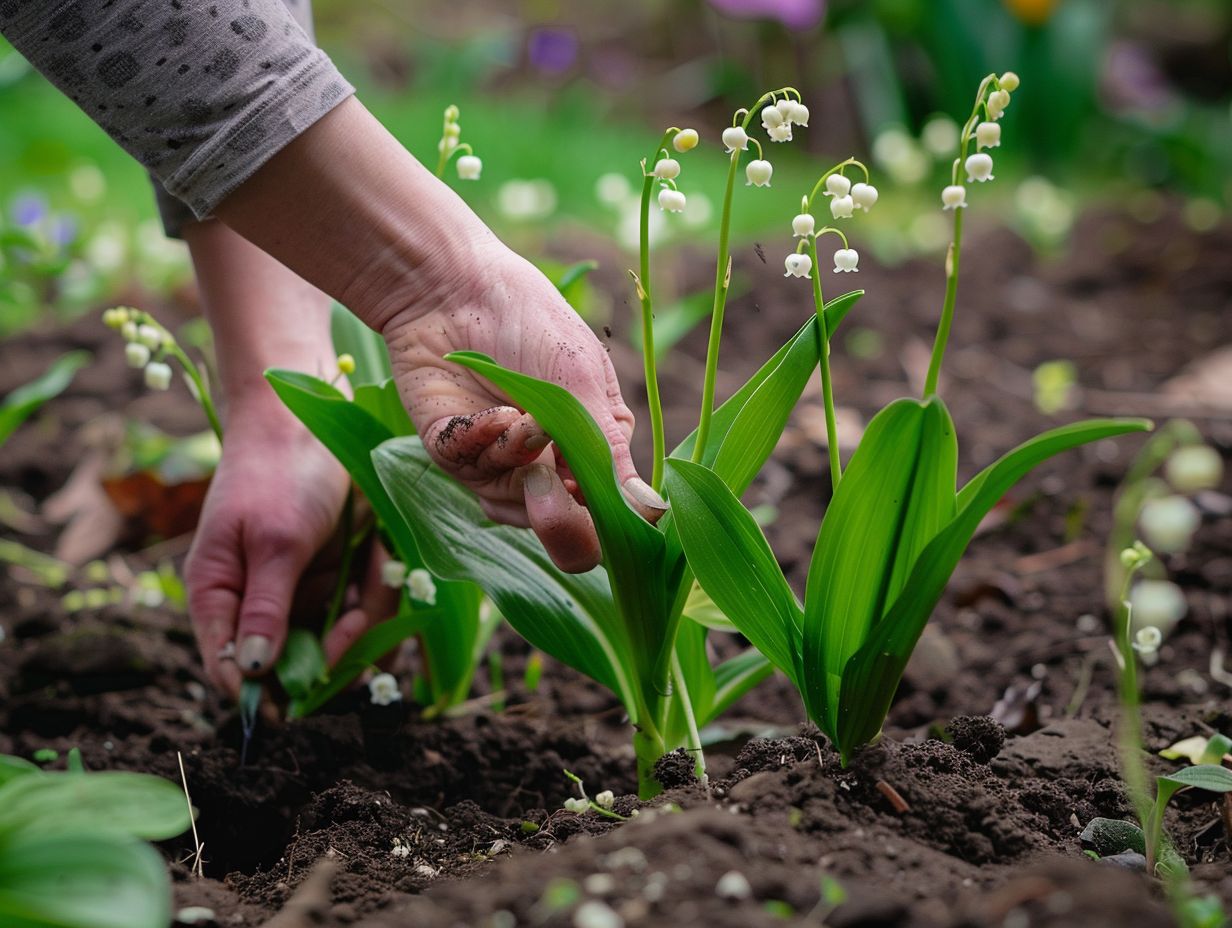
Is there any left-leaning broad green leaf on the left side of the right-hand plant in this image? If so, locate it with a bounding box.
[665,460,801,680]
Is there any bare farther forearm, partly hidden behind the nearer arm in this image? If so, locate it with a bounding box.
[184,219,335,425]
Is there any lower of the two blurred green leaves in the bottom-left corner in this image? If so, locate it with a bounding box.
[0,823,171,928]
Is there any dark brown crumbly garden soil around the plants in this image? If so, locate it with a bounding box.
[0,204,1232,928]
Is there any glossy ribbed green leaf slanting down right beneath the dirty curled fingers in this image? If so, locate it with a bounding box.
[372,438,638,718]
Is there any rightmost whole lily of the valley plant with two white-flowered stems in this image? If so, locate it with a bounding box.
[667,73,1149,763]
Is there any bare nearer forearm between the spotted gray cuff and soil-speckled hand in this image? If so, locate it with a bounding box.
[217,99,487,332]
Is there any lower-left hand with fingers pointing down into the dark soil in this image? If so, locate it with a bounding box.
[185,405,397,696]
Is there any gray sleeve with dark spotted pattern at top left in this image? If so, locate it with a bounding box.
[0,0,354,218]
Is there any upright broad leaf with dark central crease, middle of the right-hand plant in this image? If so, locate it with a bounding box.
[803,397,958,732]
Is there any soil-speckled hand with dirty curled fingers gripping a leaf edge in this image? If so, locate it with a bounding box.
[384,243,667,572]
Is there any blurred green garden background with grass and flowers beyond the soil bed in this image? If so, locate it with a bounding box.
[0,0,1232,335]
